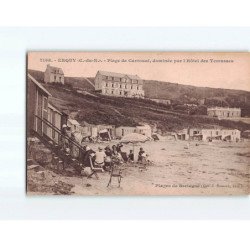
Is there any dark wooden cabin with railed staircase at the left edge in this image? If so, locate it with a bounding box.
[27,75,83,168]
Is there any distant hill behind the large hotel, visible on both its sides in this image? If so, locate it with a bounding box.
[29,70,250,116]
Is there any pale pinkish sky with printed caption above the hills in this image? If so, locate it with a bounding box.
[28,52,250,91]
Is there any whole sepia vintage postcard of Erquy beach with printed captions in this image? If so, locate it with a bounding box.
[26,52,250,195]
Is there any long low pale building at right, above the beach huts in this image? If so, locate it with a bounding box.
[207,107,241,119]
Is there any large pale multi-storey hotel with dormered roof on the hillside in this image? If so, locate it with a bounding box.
[94,71,145,98]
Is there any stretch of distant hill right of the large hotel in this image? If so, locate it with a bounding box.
[144,80,250,116]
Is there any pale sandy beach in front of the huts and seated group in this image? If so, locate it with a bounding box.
[28,141,250,195]
